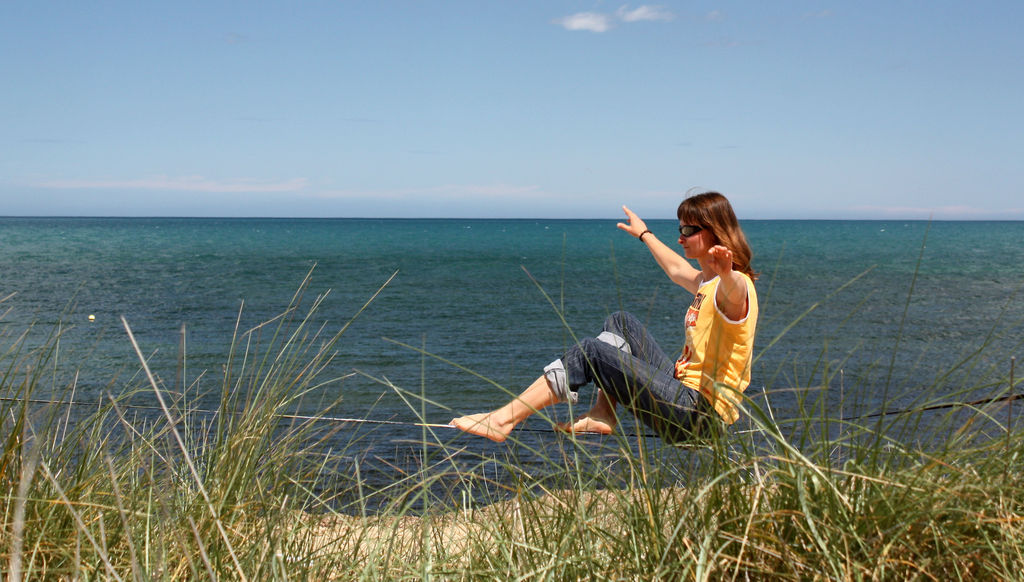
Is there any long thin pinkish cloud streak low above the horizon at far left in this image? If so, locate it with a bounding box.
[35,176,307,193]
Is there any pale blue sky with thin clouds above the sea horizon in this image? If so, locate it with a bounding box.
[0,0,1024,220]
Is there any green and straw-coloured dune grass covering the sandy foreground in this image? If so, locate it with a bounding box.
[0,274,1024,581]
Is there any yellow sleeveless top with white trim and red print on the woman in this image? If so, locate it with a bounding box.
[676,275,758,424]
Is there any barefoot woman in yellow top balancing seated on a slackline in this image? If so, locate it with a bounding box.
[452,192,758,443]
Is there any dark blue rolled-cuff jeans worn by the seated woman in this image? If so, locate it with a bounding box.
[545,311,715,442]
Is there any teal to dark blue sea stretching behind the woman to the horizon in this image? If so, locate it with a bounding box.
[0,217,1024,506]
